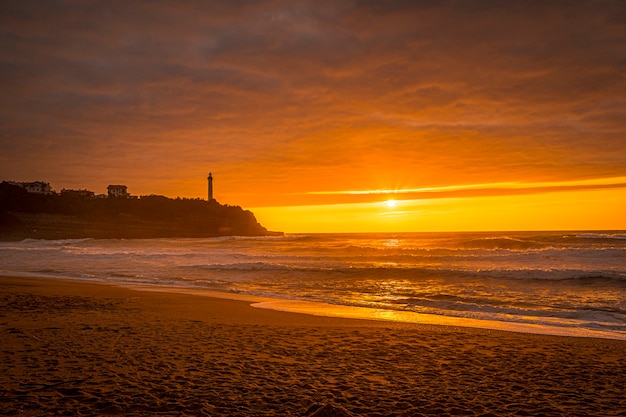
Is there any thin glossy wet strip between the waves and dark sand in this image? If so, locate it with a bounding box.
[6,274,626,341]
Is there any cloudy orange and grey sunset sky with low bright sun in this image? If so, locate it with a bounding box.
[0,0,626,233]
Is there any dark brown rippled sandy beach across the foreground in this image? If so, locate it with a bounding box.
[0,277,626,417]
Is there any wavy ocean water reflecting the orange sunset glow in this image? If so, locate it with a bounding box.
[0,231,626,340]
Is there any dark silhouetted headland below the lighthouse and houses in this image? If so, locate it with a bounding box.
[0,183,277,240]
